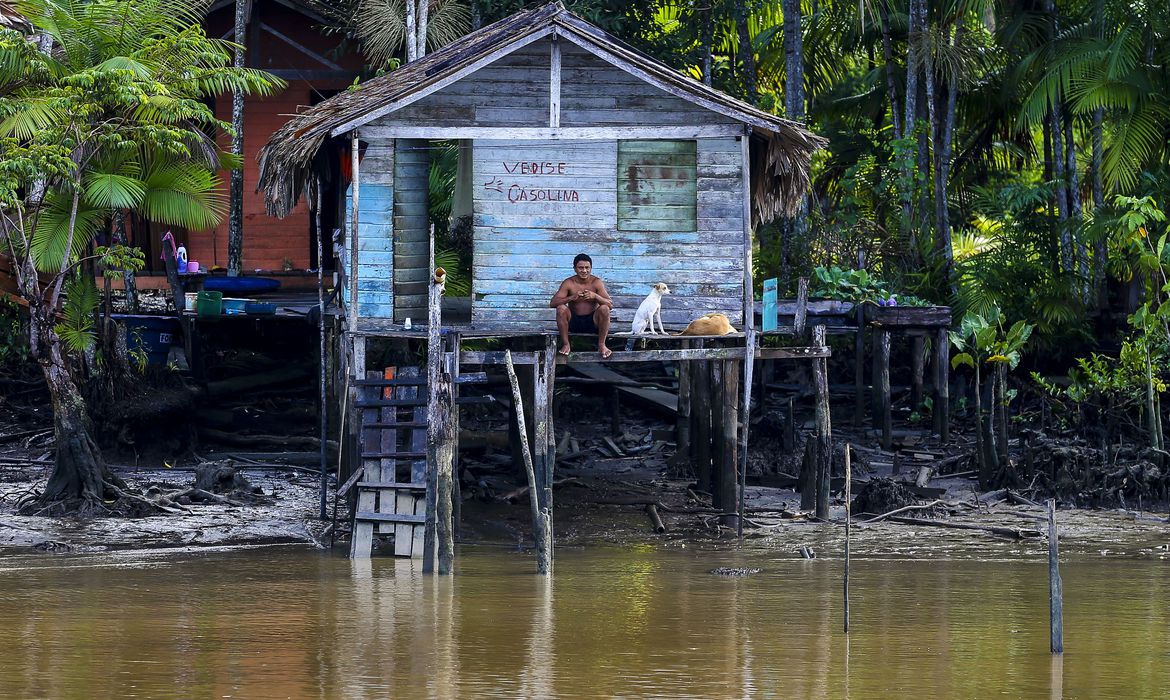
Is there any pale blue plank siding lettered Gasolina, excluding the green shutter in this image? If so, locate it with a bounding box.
[472,138,744,330]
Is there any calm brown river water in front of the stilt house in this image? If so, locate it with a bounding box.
[0,545,1170,699]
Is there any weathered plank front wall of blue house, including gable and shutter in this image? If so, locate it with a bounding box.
[359,41,744,330]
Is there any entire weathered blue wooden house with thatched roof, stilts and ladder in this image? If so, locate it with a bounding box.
[260,2,831,572]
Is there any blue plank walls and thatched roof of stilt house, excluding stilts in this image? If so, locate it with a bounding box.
[260,2,821,327]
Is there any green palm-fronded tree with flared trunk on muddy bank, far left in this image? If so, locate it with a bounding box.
[0,0,280,510]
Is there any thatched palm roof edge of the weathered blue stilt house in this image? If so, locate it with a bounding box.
[259,1,825,221]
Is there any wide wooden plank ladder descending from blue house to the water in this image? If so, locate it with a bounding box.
[350,368,427,558]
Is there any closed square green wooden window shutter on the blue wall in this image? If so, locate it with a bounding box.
[618,140,697,231]
